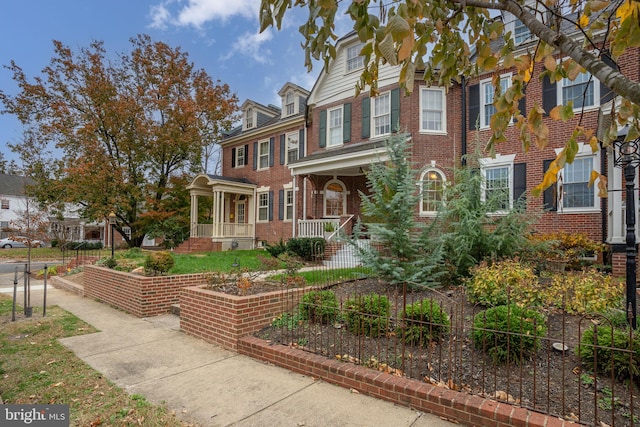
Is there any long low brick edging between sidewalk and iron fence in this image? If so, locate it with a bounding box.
[237,336,578,427]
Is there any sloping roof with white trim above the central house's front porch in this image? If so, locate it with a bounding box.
[289,139,388,176]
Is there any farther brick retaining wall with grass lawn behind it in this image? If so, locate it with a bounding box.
[84,265,204,317]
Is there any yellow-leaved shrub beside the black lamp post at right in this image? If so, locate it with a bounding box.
[544,269,624,314]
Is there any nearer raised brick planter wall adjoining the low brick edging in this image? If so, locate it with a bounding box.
[180,286,309,350]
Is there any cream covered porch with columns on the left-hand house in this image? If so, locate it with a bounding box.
[187,174,256,251]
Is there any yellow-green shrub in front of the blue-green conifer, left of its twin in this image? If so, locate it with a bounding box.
[466,260,541,306]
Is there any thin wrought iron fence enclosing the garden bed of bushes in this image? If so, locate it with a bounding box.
[261,244,640,426]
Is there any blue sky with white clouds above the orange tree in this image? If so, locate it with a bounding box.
[0,0,348,164]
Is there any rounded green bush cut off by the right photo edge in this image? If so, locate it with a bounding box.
[576,325,640,379]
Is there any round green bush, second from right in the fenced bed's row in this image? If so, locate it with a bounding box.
[471,304,547,363]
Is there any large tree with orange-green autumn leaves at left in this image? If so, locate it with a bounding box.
[0,35,238,246]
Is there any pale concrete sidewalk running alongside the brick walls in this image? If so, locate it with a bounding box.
[32,289,454,427]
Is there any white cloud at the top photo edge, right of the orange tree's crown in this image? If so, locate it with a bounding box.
[151,0,260,28]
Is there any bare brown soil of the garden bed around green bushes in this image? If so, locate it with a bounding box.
[256,280,640,426]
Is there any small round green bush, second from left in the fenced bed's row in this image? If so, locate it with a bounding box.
[344,294,391,337]
